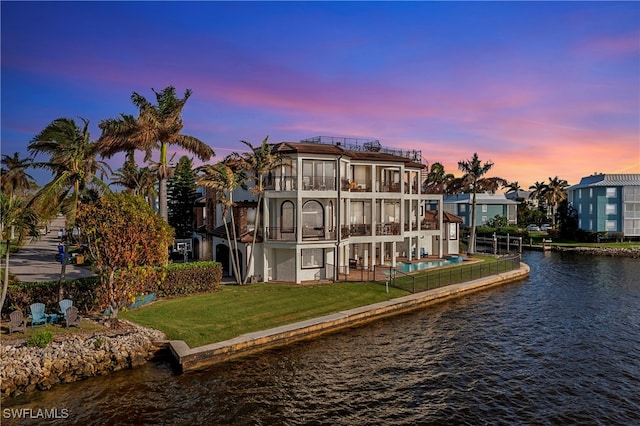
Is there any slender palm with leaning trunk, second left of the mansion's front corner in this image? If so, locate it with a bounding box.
[198,157,245,284]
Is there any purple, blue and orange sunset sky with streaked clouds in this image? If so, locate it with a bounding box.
[0,0,640,189]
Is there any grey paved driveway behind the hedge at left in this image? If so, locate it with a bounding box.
[9,217,93,282]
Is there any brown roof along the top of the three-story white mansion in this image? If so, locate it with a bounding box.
[273,142,427,168]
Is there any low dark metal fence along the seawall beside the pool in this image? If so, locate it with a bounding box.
[375,255,520,293]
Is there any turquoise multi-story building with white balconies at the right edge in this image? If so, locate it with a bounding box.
[567,174,640,237]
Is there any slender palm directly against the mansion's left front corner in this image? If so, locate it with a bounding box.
[239,136,282,284]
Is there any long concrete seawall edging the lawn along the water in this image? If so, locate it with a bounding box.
[168,263,530,372]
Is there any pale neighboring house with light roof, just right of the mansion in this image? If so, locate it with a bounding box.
[444,193,520,226]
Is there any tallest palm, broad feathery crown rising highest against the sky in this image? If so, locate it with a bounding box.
[99,86,215,221]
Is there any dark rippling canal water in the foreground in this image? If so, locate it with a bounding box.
[2,252,640,425]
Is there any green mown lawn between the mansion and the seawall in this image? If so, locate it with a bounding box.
[119,282,407,347]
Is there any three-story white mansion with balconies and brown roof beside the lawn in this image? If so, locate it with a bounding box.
[204,137,461,283]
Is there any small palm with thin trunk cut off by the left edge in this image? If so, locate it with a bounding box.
[0,194,40,311]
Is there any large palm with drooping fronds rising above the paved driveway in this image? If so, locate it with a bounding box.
[28,118,111,228]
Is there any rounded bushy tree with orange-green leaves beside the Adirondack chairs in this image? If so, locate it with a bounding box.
[77,192,173,323]
